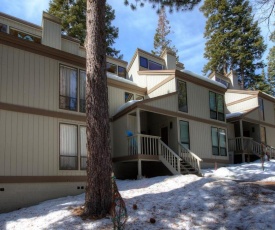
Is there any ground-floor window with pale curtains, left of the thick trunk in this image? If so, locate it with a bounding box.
[59,124,87,170]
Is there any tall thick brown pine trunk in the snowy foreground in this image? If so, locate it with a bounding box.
[84,0,112,218]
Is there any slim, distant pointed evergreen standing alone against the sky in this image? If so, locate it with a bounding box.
[152,8,178,59]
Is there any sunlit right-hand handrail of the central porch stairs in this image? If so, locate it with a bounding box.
[178,143,203,174]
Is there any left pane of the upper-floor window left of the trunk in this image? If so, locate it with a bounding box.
[59,66,77,111]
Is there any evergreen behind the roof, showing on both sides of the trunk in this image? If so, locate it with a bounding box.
[48,0,122,58]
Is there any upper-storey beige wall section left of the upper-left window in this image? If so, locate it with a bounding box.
[0,44,59,110]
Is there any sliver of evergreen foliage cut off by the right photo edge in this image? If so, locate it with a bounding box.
[267,31,275,96]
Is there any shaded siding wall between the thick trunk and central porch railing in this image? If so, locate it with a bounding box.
[113,115,128,157]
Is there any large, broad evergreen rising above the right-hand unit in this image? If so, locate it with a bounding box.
[201,0,266,88]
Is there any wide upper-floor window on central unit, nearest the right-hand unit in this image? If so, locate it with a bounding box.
[209,92,224,121]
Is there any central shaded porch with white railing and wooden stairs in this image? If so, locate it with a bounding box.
[113,109,202,178]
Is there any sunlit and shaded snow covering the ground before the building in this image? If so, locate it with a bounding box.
[0,160,275,230]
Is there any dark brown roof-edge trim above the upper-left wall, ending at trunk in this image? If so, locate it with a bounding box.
[0,33,86,68]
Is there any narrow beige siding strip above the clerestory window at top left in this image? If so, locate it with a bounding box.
[0,16,42,37]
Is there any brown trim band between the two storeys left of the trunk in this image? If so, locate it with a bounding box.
[0,102,86,122]
